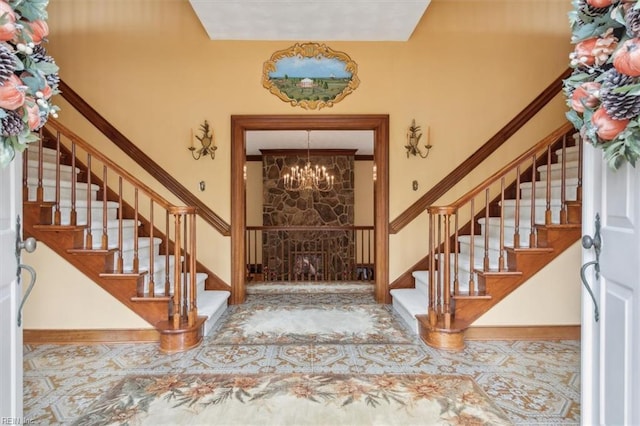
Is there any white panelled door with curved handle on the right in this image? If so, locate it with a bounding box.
[581,144,640,426]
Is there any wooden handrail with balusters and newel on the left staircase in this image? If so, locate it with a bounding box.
[36,119,199,338]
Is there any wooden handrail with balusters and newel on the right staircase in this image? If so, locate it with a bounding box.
[427,122,582,336]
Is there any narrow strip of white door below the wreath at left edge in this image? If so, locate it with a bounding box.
[0,155,22,416]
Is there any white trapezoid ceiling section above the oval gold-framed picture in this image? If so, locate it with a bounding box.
[189,0,431,42]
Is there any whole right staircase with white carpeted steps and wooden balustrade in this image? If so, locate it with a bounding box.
[391,123,582,350]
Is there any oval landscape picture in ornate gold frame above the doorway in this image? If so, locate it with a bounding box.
[262,43,360,109]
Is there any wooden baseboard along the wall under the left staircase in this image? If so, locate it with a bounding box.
[22,328,160,345]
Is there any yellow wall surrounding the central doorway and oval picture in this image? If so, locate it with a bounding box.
[26,0,579,328]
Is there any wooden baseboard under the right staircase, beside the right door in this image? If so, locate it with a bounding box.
[464,325,580,340]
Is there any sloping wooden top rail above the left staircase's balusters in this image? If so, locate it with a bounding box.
[46,118,190,214]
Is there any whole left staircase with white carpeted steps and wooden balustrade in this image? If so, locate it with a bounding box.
[23,120,230,352]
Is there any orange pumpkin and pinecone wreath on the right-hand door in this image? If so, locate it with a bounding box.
[564,0,640,169]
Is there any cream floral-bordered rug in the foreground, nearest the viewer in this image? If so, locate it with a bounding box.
[74,374,511,426]
